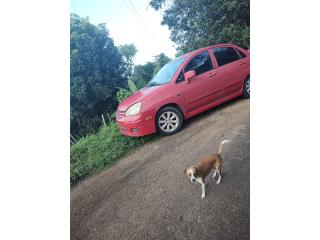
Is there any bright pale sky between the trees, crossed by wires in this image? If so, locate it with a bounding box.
[71,0,176,64]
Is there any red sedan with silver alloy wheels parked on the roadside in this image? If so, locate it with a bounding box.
[116,44,250,137]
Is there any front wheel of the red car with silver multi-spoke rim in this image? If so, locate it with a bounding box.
[156,106,183,136]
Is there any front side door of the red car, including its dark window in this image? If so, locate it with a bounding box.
[181,50,222,112]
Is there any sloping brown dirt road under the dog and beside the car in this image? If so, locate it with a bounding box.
[71,99,250,240]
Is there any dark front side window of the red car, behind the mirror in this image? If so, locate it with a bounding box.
[184,51,213,75]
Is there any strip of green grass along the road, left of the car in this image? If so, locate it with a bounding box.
[70,122,157,187]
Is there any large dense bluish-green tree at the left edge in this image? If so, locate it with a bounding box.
[70,14,127,134]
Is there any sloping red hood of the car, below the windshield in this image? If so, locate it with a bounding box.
[118,85,165,111]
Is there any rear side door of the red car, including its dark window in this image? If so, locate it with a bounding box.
[212,47,246,97]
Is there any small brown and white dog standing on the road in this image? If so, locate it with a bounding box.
[184,140,230,198]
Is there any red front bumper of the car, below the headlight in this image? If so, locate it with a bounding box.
[116,111,156,137]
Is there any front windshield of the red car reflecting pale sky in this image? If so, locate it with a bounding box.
[146,57,184,87]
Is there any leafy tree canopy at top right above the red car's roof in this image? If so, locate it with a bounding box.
[150,0,250,52]
